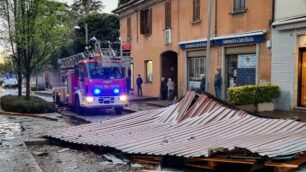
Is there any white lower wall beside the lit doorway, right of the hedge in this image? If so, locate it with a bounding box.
[271,29,296,110]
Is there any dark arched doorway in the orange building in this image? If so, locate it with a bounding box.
[161,51,178,96]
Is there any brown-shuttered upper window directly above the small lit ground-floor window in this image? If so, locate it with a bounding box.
[140,9,152,35]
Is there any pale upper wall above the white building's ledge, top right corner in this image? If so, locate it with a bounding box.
[275,0,306,20]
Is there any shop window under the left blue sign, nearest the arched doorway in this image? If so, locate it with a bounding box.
[188,57,206,89]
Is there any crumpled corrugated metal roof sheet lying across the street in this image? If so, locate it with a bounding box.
[47,92,306,157]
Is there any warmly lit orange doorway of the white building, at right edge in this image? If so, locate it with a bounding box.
[298,49,306,107]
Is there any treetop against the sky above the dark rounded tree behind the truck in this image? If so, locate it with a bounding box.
[72,0,104,16]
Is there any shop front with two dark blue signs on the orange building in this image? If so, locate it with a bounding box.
[180,31,265,98]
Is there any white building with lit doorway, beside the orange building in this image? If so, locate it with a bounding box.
[271,0,306,110]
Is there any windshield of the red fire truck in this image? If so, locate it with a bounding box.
[87,62,124,79]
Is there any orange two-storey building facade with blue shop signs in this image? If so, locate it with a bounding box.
[114,0,273,98]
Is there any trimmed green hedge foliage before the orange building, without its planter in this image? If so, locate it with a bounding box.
[228,85,280,105]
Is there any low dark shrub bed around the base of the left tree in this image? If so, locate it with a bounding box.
[1,96,55,114]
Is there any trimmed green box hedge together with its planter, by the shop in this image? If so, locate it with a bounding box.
[228,84,280,112]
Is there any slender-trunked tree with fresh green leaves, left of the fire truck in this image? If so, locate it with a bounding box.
[1,0,69,100]
